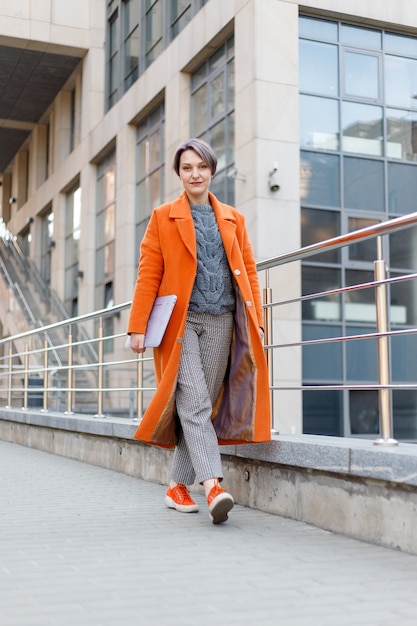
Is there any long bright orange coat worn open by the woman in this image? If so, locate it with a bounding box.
[127,192,271,448]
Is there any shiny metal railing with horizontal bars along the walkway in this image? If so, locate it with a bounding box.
[0,213,417,445]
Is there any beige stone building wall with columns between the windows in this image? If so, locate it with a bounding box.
[0,0,417,432]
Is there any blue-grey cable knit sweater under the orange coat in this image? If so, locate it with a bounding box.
[189,204,235,315]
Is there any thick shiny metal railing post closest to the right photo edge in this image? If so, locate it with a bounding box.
[374,235,398,446]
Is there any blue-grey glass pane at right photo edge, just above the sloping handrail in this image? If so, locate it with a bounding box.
[388,163,417,213]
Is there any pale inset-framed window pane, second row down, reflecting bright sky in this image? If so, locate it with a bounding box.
[344,50,380,100]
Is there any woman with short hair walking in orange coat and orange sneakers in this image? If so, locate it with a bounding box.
[128,139,271,524]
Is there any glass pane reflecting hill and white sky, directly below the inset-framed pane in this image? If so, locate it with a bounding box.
[342,102,383,156]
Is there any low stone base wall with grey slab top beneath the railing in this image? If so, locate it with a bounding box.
[0,409,417,554]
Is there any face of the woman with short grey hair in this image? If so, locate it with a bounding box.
[179,150,212,204]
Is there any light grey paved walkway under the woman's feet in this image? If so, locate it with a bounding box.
[0,441,417,626]
